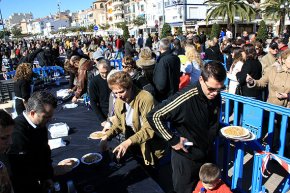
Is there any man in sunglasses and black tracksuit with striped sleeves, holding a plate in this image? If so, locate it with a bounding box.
[147,61,226,193]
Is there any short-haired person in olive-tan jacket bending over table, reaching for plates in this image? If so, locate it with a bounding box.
[101,71,166,165]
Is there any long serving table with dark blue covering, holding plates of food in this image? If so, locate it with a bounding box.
[48,88,164,193]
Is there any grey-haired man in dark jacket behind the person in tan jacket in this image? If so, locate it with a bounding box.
[89,59,111,126]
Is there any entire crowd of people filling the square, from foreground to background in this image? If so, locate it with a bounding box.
[0,29,290,193]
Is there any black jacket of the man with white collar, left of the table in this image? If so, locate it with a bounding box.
[8,114,53,193]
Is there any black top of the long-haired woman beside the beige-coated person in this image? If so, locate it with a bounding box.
[236,59,262,99]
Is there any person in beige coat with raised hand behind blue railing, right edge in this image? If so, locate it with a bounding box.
[246,50,290,108]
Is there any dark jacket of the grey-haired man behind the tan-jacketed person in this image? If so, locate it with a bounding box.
[89,75,111,122]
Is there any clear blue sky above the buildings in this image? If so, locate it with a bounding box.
[0,0,95,19]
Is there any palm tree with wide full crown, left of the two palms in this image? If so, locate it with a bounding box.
[204,0,256,30]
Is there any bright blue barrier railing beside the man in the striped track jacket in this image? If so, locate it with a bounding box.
[220,92,290,193]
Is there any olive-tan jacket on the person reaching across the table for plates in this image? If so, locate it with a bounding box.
[107,87,166,165]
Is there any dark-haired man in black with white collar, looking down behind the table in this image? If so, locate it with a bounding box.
[8,91,57,193]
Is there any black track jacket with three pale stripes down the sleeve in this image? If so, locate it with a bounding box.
[147,81,221,160]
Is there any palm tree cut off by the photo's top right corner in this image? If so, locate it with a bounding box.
[260,0,289,34]
